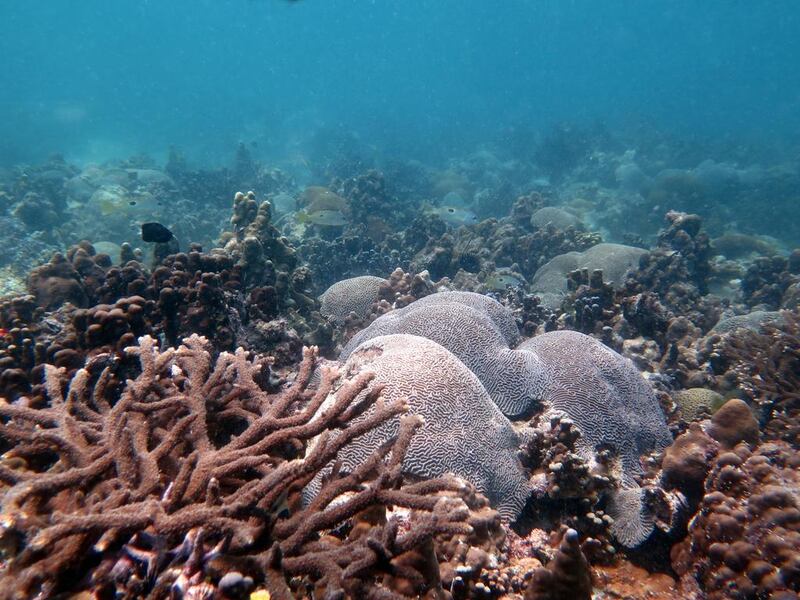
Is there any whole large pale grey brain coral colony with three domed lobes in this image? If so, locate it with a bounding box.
[316,288,671,545]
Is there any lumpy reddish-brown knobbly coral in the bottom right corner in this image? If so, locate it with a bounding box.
[671,442,800,600]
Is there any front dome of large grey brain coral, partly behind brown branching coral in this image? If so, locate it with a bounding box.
[312,335,530,520]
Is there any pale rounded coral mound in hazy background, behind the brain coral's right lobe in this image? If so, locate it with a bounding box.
[531,243,647,308]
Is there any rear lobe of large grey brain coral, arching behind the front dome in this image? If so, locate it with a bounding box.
[339,294,546,417]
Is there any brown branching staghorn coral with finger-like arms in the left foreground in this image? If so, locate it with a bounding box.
[0,335,488,598]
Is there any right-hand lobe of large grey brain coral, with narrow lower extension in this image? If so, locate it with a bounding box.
[517,331,672,547]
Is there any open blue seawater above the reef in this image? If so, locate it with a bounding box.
[0,0,800,164]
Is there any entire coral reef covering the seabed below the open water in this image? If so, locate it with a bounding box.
[0,130,800,600]
